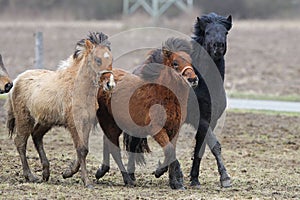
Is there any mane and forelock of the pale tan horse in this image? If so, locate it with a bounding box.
[73,32,111,59]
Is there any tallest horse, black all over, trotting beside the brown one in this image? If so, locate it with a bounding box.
[123,13,232,187]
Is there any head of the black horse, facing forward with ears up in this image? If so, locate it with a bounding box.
[194,13,232,60]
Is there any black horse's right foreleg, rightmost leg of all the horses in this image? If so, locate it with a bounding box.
[207,129,231,187]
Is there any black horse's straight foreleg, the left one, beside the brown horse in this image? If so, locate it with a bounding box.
[190,119,209,187]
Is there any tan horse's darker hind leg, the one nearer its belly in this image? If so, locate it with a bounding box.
[32,124,51,181]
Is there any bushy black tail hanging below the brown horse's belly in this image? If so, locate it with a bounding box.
[123,132,151,165]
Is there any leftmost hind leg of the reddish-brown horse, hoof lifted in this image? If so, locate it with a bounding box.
[95,134,110,179]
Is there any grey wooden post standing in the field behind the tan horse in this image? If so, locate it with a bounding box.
[34,32,44,69]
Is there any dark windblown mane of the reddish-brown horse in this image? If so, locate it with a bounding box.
[136,37,192,80]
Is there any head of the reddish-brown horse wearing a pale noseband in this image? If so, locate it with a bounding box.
[162,47,198,87]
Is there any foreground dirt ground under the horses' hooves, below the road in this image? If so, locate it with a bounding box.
[0,97,300,199]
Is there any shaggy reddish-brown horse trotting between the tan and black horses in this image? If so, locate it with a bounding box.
[96,38,198,189]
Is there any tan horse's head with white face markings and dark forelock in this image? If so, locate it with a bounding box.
[74,32,116,91]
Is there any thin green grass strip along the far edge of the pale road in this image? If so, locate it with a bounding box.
[227,91,300,102]
